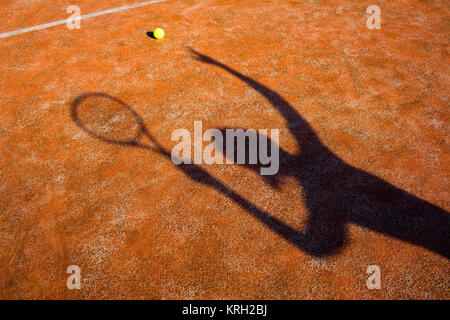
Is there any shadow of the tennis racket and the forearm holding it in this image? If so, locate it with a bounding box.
[71,92,309,250]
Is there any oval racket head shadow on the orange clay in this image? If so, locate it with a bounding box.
[71,92,153,148]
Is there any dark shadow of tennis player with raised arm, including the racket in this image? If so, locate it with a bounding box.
[71,49,450,258]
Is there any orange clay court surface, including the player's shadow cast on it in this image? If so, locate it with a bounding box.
[0,0,450,299]
